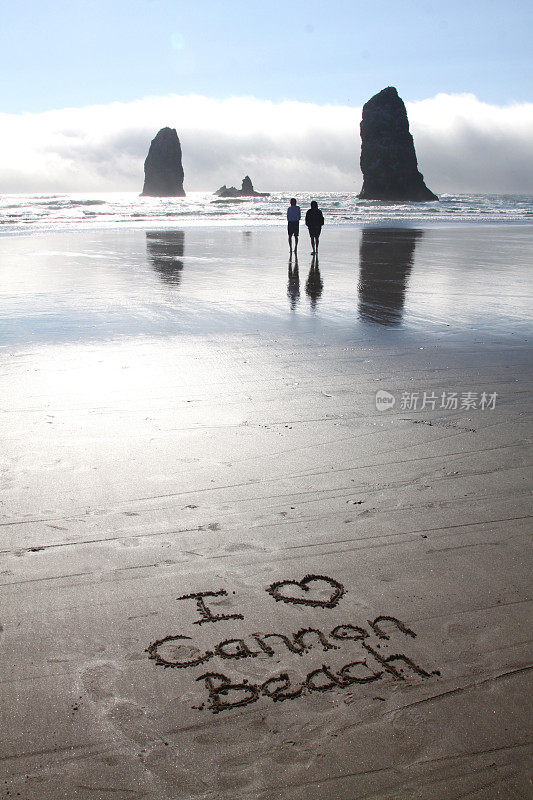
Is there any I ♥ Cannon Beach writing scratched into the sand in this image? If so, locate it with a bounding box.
[146,575,440,714]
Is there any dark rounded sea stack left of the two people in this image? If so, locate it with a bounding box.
[142,128,185,197]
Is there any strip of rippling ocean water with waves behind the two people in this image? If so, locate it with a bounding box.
[0,192,533,235]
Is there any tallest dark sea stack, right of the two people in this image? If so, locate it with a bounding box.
[359,86,439,202]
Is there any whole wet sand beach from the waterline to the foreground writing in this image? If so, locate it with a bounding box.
[0,225,533,800]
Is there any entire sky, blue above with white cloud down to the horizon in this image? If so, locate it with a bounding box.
[0,0,533,193]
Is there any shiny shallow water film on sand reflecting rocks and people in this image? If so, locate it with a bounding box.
[0,226,533,348]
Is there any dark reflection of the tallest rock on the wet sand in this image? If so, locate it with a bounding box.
[359,228,423,325]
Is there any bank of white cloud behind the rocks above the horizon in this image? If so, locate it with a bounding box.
[0,94,533,193]
